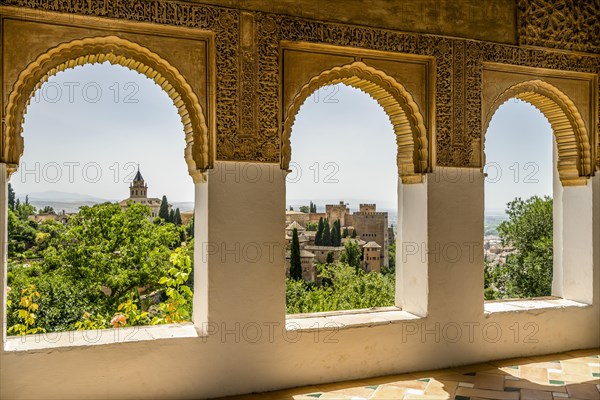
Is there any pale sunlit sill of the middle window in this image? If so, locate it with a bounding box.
[285,307,421,332]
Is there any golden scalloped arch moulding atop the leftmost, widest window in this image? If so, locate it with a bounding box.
[2,36,214,179]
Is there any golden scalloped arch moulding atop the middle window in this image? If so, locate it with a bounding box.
[281,61,430,183]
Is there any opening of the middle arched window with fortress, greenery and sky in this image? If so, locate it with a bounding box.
[286,83,398,313]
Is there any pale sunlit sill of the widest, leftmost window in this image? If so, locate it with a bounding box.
[4,322,200,352]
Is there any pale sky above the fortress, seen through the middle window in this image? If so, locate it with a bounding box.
[286,84,398,209]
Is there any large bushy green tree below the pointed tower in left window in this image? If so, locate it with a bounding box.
[44,203,179,308]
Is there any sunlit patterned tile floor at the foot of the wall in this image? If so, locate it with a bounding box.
[220,349,600,400]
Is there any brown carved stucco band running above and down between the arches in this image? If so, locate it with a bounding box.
[3,0,600,172]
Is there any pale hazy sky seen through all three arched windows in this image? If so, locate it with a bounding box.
[11,63,552,209]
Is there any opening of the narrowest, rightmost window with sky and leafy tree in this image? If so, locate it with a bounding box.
[484,98,560,300]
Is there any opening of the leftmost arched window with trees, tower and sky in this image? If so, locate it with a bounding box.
[2,62,194,335]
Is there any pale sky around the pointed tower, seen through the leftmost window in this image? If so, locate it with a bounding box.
[11,63,194,201]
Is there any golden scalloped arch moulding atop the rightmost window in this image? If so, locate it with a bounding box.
[483,80,594,186]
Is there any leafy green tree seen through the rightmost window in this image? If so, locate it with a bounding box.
[485,196,553,298]
